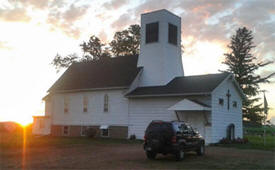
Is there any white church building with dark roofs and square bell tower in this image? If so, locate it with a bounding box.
[33,10,245,143]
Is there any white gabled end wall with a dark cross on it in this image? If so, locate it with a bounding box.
[211,79,243,143]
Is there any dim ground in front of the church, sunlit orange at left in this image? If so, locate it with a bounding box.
[0,134,275,170]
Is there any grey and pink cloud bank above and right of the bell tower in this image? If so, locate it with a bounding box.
[132,0,275,65]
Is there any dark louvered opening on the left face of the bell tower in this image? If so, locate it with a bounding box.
[145,21,159,44]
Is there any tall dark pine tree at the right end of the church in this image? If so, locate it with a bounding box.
[223,27,275,123]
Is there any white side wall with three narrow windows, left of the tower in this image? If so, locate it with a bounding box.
[52,90,128,126]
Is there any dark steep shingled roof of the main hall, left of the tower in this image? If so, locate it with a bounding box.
[48,56,141,92]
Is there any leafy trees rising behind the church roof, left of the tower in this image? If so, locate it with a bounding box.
[51,25,140,71]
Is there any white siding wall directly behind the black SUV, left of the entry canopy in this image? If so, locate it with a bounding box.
[128,97,180,139]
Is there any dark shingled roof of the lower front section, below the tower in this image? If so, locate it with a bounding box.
[126,73,229,97]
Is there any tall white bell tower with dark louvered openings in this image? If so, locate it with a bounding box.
[138,9,184,86]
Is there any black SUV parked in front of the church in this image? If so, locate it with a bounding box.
[143,121,205,160]
